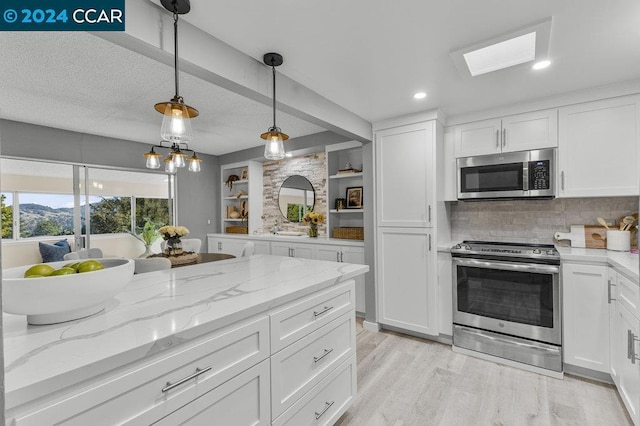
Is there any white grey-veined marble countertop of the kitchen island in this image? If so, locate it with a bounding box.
[3,255,369,408]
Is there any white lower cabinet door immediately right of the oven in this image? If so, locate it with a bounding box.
[562,263,609,373]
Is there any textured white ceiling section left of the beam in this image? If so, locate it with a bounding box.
[0,32,325,155]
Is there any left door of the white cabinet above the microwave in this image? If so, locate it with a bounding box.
[454,118,502,157]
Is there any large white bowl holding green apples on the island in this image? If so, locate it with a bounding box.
[2,258,135,325]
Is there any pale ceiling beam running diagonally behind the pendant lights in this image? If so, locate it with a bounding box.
[93,0,373,142]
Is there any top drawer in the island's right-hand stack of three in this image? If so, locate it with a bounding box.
[271,280,355,353]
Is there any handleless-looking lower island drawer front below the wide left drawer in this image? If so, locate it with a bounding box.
[153,360,270,426]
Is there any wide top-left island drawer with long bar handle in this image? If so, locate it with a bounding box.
[15,316,269,426]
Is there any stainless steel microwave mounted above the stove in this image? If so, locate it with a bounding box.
[457,148,556,200]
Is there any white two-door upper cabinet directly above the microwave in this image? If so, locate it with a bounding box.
[454,109,558,157]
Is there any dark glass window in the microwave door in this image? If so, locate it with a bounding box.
[460,163,523,192]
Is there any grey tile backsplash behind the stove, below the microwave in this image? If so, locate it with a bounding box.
[449,197,638,245]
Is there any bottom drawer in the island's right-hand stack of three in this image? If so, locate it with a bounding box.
[273,355,357,426]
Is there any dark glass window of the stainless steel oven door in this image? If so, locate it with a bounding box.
[457,266,553,328]
